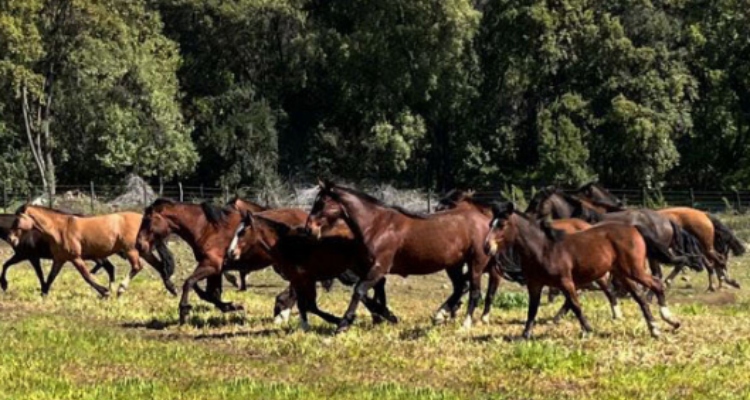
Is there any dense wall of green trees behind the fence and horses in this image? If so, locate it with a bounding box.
[0,0,750,189]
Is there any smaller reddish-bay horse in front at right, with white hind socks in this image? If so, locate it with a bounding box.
[485,203,680,339]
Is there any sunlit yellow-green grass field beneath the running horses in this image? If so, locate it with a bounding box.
[0,217,750,399]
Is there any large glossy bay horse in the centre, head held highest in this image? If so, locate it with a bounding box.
[305,182,490,332]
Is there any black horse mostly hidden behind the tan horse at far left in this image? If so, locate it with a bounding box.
[0,214,115,291]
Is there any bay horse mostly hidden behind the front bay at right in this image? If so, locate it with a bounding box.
[435,189,622,323]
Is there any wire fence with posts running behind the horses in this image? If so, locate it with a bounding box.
[2,181,750,214]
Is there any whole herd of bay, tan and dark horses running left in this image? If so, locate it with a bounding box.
[0,181,745,338]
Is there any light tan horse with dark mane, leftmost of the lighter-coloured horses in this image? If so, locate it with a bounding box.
[8,204,174,296]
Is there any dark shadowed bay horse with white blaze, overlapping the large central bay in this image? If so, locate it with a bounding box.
[227,209,398,331]
